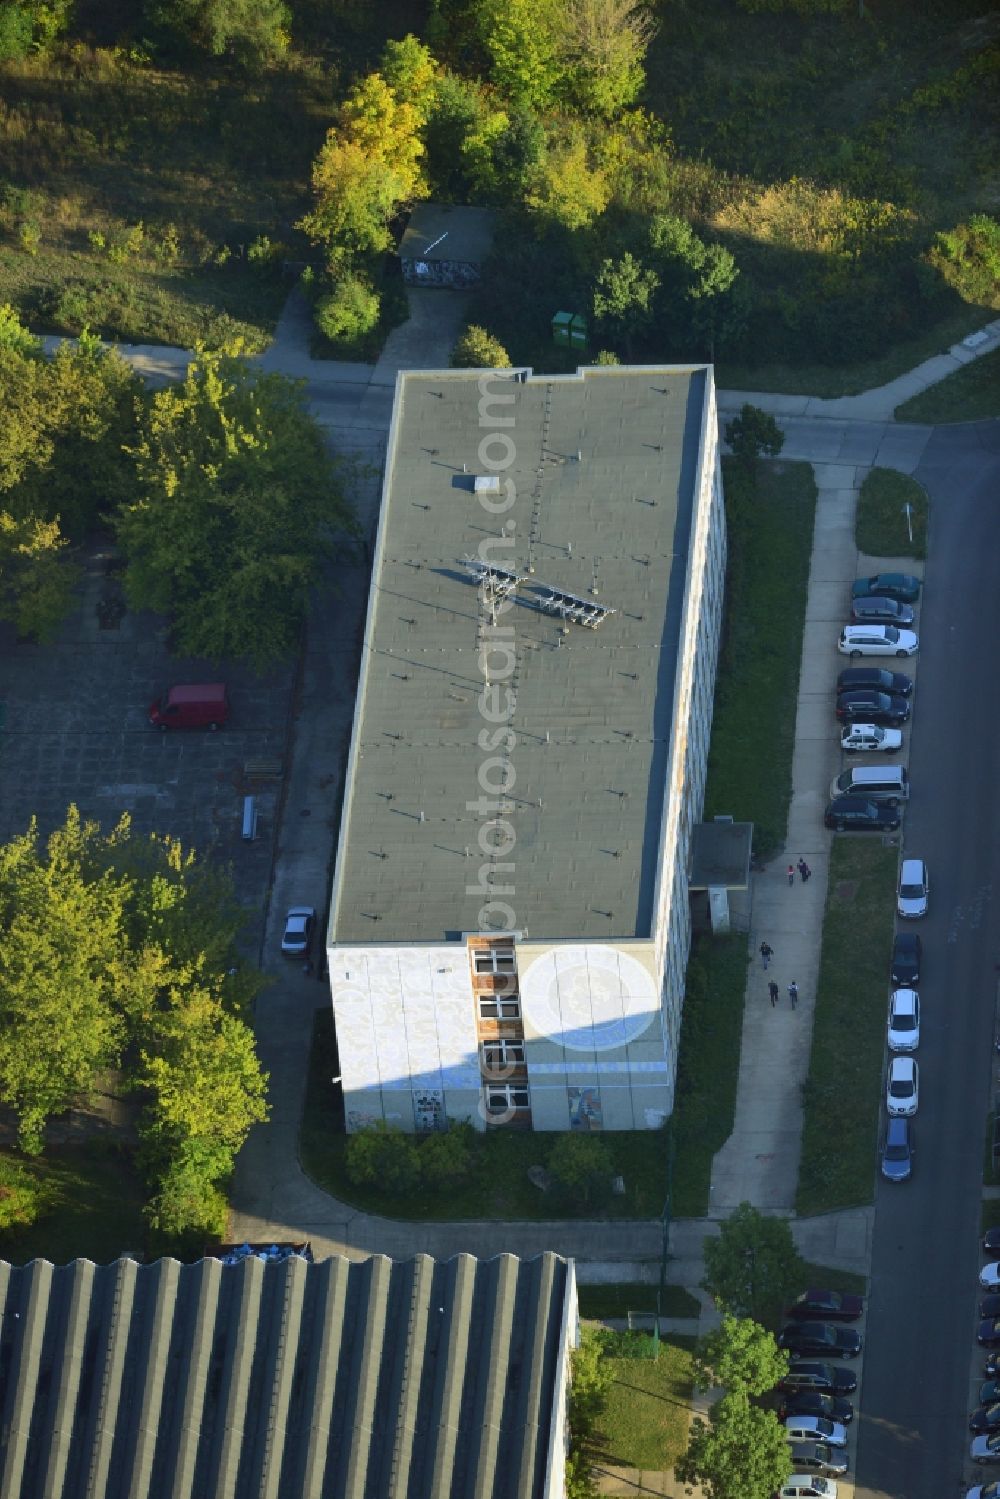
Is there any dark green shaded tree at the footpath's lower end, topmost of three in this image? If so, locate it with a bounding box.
[702,1202,805,1327]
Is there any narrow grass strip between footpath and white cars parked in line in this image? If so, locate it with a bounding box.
[795,835,898,1216]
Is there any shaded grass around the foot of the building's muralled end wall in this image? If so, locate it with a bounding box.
[298,1009,667,1222]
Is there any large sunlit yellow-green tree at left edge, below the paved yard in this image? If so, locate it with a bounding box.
[0,808,131,1154]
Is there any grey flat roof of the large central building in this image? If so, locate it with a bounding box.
[330,366,708,946]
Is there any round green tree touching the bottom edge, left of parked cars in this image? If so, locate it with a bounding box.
[675,1390,792,1499]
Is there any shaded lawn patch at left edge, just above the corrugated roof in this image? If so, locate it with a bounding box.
[0,1141,148,1265]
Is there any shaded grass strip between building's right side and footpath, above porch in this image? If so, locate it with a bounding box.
[705,460,816,857]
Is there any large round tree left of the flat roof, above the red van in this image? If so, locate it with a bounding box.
[115,348,352,667]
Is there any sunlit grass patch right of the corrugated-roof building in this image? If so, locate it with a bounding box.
[594,1337,694,1472]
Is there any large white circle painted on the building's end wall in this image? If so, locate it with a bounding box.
[520,946,660,1051]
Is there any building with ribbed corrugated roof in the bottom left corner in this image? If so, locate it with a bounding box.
[0,1255,577,1499]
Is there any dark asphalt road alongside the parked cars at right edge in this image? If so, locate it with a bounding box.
[844,423,1000,1499]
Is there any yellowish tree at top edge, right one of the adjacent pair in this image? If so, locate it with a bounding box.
[558,0,657,118]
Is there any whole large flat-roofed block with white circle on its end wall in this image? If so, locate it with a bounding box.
[327,366,726,1130]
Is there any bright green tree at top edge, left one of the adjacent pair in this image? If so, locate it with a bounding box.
[477,0,565,109]
